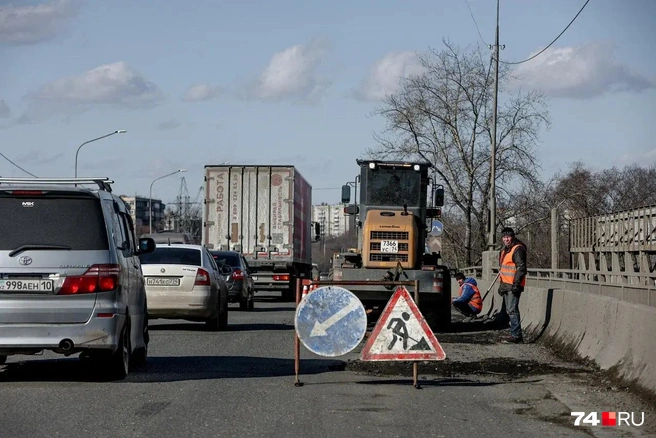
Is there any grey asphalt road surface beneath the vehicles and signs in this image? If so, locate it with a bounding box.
[0,296,656,438]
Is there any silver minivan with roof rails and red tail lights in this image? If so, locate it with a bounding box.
[0,178,155,379]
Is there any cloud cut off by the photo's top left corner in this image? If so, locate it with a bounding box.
[0,0,81,44]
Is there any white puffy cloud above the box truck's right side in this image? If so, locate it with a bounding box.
[250,40,330,102]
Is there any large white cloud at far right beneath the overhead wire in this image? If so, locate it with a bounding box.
[511,43,656,99]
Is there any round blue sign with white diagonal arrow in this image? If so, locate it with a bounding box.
[294,286,367,357]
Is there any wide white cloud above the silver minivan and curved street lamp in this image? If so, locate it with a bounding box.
[21,61,163,121]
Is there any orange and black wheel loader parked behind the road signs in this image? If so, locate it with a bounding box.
[330,160,451,330]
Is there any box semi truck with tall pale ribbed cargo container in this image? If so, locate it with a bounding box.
[202,164,319,301]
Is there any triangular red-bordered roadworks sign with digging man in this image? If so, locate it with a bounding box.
[360,286,446,361]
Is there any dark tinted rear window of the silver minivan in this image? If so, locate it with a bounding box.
[0,194,109,251]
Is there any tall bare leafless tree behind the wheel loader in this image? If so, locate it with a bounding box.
[367,40,549,265]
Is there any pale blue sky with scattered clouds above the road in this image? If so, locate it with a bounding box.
[0,0,656,204]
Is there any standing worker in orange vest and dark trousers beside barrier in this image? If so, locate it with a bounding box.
[498,227,527,344]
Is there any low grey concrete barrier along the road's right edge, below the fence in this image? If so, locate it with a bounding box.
[452,279,656,394]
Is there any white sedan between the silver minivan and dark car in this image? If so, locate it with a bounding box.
[139,243,230,330]
